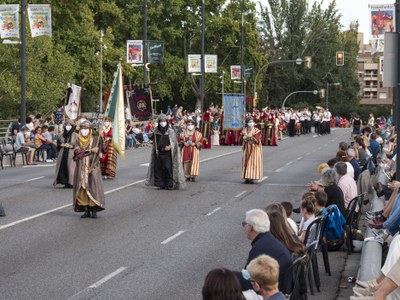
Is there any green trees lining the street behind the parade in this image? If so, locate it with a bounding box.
[0,0,374,118]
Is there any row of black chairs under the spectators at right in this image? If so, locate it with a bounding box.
[289,193,368,300]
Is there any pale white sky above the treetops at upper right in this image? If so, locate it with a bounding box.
[260,0,386,44]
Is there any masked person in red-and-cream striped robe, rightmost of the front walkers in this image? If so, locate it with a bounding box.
[241,117,263,183]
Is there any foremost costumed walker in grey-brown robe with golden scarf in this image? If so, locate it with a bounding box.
[73,121,105,218]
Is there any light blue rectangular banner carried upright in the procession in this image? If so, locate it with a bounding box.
[223,94,246,130]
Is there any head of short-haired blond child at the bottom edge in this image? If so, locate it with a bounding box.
[247,255,286,300]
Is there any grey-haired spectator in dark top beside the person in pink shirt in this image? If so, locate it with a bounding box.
[308,169,346,214]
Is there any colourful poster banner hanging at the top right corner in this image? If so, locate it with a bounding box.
[369,4,396,54]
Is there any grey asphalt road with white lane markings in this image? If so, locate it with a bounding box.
[0,129,350,300]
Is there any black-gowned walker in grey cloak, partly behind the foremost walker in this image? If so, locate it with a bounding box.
[53,120,78,188]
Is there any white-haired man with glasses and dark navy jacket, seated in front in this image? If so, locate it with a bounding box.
[240,209,292,292]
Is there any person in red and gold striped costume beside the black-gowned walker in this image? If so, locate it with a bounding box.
[179,119,203,181]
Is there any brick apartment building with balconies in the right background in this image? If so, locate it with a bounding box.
[357,33,393,105]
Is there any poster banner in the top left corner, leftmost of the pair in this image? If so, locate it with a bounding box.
[0,4,19,39]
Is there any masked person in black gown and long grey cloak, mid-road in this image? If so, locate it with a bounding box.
[146,114,186,190]
